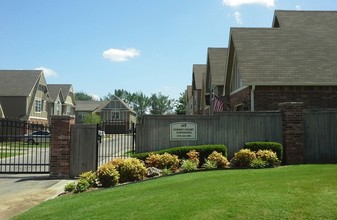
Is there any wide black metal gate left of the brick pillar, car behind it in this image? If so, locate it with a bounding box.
[0,119,50,173]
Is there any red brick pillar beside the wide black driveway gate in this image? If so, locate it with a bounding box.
[49,116,75,178]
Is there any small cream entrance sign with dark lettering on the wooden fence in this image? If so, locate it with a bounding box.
[170,122,197,141]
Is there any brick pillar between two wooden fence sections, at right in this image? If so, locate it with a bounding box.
[278,102,304,164]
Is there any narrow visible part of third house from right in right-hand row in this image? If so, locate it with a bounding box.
[192,64,206,115]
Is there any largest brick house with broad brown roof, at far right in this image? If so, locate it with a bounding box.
[223,11,337,111]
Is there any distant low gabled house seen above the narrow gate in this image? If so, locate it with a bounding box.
[75,96,137,124]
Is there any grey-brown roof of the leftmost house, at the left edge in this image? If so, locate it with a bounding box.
[0,70,44,96]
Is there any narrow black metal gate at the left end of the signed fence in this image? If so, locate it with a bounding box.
[97,121,136,166]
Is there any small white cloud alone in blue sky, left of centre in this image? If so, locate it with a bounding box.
[103,48,140,62]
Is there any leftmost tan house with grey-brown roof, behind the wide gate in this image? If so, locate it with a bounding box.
[0,70,51,124]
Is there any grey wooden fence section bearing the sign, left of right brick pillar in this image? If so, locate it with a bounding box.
[136,112,282,157]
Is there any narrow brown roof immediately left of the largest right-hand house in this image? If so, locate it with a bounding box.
[207,48,228,85]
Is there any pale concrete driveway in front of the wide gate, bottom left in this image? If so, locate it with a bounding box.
[0,174,72,219]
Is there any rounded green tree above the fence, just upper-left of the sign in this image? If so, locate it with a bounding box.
[150,93,174,115]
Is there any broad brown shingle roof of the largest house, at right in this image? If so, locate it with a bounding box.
[226,11,337,86]
